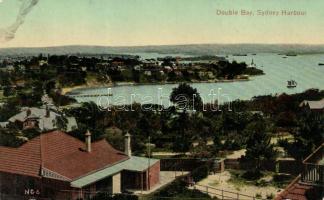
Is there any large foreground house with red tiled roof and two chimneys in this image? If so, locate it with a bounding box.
[0,131,160,200]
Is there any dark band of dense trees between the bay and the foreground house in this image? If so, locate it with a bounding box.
[0,79,324,162]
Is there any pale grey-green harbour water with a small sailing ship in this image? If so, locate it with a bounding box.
[66,53,324,106]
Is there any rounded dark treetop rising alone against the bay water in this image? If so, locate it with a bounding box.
[170,83,202,111]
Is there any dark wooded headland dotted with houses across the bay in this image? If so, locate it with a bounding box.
[0,54,263,91]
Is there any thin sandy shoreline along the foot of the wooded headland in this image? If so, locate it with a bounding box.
[61,76,251,95]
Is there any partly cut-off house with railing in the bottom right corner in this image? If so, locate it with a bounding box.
[275,143,324,200]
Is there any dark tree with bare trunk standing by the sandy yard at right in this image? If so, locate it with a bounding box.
[244,119,276,175]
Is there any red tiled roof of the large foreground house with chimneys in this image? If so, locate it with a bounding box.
[0,131,128,180]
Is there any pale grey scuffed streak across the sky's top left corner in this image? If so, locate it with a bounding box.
[0,0,39,43]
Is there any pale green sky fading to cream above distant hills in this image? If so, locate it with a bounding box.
[0,0,324,48]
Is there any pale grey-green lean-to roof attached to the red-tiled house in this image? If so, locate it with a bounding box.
[71,156,159,188]
